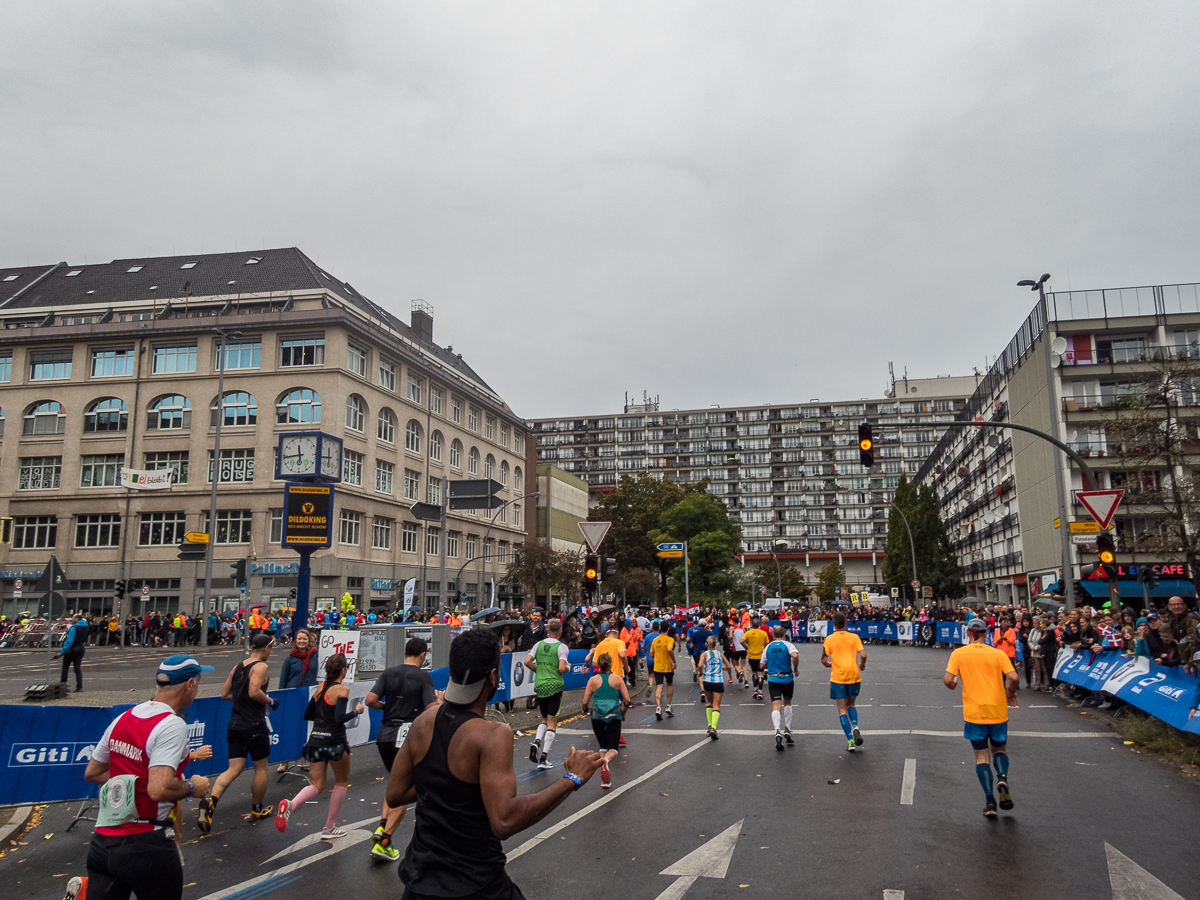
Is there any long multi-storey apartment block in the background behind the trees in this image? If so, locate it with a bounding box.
[529,377,978,586]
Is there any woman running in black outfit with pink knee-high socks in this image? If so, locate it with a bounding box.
[275,644,362,841]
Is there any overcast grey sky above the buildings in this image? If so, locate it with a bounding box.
[0,0,1200,418]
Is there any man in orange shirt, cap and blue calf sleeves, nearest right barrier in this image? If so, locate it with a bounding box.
[942,619,1020,818]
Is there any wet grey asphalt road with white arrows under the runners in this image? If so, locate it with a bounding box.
[0,646,1200,900]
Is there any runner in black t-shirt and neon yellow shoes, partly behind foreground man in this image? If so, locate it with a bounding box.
[364,637,442,863]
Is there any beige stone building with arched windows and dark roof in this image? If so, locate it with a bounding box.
[0,248,534,613]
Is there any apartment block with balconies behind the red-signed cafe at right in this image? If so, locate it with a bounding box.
[918,284,1200,602]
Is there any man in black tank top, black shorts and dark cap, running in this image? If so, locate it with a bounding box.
[197,634,280,834]
